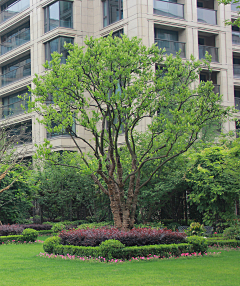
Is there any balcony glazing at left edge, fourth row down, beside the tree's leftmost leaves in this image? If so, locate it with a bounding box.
[2,89,31,118]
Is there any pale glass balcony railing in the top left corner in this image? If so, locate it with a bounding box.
[0,0,30,23]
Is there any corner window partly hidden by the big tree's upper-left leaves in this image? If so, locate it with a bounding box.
[45,37,73,63]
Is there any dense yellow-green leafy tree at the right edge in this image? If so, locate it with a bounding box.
[186,143,240,228]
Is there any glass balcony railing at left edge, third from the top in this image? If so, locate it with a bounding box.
[1,63,31,86]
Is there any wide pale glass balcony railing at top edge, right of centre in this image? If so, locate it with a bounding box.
[153,0,184,19]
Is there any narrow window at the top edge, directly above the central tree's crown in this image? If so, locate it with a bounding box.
[102,0,123,27]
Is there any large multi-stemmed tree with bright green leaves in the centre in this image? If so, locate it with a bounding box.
[31,35,230,230]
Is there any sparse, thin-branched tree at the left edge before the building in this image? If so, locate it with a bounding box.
[0,118,32,194]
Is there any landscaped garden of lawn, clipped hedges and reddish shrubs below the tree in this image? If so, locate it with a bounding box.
[0,224,240,285]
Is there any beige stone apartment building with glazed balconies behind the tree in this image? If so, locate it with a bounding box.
[0,0,240,156]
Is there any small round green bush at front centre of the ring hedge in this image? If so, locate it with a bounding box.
[98,239,125,260]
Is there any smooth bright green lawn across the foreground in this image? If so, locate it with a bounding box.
[0,240,240,286]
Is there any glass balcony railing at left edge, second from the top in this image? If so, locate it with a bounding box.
[0,29,30,55]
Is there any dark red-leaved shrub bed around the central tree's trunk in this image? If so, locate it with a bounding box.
[59,227,186,246]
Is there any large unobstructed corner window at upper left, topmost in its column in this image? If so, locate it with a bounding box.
[44,1,73,33]
